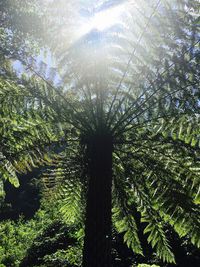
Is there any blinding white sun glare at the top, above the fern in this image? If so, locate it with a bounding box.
[80,4,124,35]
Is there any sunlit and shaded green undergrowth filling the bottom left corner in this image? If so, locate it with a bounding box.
[0,196,81,267]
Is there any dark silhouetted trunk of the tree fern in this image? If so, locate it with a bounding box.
[83,136,113,267]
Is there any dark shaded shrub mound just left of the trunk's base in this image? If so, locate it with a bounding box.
[20,221,81,267]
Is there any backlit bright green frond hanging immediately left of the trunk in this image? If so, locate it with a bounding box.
[41,143,86,225]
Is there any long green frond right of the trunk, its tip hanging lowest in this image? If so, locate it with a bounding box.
[114,151,175,262]
